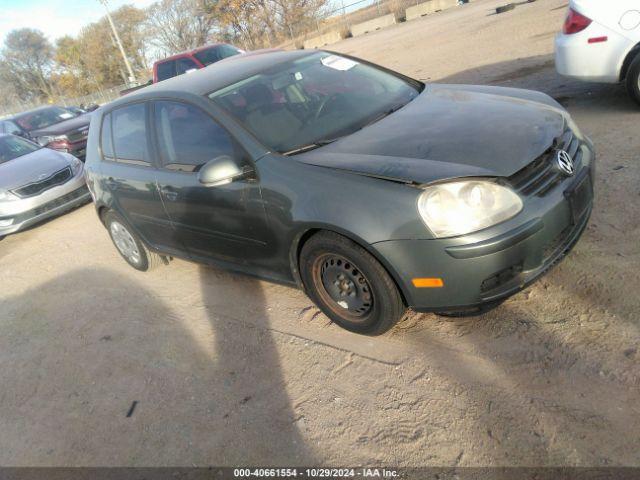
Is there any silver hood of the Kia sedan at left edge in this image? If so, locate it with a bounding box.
[0,148,69,190]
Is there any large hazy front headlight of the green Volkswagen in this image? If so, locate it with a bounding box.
[418,180,522,238]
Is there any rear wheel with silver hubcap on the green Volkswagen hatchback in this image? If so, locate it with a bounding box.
[104,211,166,272]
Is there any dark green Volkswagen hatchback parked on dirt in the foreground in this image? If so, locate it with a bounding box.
[87,51,595,334]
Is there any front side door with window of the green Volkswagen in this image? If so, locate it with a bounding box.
[152,101,267,264]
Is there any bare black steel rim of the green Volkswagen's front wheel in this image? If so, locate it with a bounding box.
[320,255,373,316]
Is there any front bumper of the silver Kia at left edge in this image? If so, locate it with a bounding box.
[0,170,91,235]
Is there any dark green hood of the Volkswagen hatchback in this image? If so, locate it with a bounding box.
[294,85,568,184]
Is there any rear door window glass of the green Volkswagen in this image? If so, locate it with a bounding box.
[111,103,149,163]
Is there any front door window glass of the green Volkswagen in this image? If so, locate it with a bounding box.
[154,101,240,172]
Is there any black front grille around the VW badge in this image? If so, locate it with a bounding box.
[508,129,582,197]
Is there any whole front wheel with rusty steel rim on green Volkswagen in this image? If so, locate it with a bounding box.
[300,232,406,335]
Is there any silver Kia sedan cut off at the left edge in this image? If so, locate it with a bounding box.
[0,134,91,237]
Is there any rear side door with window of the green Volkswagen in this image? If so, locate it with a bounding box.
[101,102,181,253]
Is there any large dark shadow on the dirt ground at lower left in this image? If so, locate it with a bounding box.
[0,267,314,466]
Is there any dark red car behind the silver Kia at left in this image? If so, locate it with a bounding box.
[11,106,91,160]
